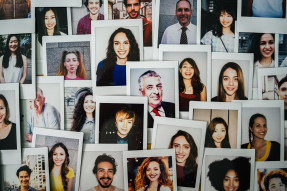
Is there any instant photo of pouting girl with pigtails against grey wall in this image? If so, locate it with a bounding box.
[43,35,91,80]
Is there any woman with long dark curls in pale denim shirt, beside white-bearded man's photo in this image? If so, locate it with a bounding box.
[71,89,96,143]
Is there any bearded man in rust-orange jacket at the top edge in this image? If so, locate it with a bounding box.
[124,0,152,46]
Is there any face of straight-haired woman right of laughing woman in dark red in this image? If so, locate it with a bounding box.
[222,68,238,96]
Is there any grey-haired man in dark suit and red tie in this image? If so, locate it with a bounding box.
[138,70,175,128]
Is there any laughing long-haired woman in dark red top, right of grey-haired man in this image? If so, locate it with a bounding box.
[178,58,206,111]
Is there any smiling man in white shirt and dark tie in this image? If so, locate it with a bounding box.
[161,0,196,44]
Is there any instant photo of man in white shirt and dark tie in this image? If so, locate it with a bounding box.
[156,0,199,48]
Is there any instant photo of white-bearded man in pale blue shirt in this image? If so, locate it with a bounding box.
[20,76,64,147]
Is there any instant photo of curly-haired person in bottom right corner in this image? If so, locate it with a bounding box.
[254,161,287,191]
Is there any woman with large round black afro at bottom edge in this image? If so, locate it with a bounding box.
[207,157,251,191]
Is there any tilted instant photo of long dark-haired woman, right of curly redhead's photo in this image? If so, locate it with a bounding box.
[151,117,207,190]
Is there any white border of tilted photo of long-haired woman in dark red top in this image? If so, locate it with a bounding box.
[151,117,207,191]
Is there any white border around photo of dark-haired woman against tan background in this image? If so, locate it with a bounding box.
[189,101,244,149]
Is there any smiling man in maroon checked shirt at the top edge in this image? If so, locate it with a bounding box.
[77,0,104,34]
